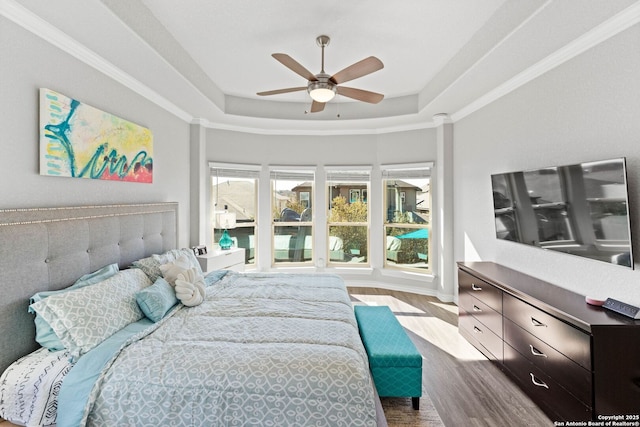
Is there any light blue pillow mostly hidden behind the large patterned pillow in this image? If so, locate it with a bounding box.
[29,263,119,351]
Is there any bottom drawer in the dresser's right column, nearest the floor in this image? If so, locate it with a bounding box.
[504,344,592,421]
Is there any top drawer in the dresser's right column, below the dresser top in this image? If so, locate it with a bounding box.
[504,294,591,371]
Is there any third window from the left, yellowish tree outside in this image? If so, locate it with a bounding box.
[327,168,371,266]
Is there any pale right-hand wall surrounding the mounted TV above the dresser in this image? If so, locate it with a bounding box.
[454,25,640,305]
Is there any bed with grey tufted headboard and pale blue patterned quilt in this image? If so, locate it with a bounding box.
[0,203,384,426]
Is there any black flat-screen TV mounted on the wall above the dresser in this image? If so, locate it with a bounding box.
[491,158,633,268]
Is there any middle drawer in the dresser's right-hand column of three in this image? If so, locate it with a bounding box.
[504,319,592,405]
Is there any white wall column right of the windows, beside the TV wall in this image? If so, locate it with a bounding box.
[432,113,456,301]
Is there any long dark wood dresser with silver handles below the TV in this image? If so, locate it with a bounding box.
[458,262,640,421]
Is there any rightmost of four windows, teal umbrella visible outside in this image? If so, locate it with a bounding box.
[382,164,431,272]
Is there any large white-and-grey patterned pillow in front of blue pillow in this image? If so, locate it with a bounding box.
[30,268,151,357]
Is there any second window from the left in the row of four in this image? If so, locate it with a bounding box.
[270,168,315,265]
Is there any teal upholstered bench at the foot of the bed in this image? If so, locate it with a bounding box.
[354,305,422,409]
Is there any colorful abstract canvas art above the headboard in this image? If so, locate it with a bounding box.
[40,88,153,183]
